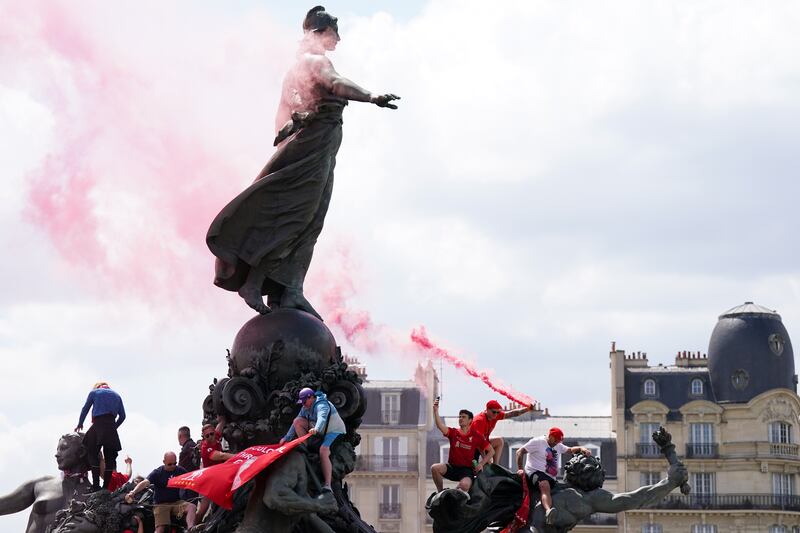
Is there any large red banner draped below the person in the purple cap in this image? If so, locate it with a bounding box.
[167,435,310,509]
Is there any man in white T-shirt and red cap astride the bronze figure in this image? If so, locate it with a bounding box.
[517,427,592,525]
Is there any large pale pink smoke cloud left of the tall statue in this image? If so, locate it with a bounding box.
[0,0,299,312]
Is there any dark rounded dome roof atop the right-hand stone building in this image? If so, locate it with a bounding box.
[708,302,796,403]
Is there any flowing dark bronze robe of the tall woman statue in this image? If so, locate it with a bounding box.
[206,100,346,294]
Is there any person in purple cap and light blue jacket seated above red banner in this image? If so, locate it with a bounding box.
[280,387,347,492]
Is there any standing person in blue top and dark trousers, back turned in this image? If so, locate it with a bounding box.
[75,381,125,491]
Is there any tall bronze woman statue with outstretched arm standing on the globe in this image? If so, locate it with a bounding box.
[206,6,399,318]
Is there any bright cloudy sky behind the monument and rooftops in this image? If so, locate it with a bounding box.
[0,0,800,530]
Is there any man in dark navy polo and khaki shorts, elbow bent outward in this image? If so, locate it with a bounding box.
[125,452,197,533]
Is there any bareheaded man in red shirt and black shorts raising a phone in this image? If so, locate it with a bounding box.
[431,398,494,501]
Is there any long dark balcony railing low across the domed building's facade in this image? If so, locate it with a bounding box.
[648,494,800,511]
